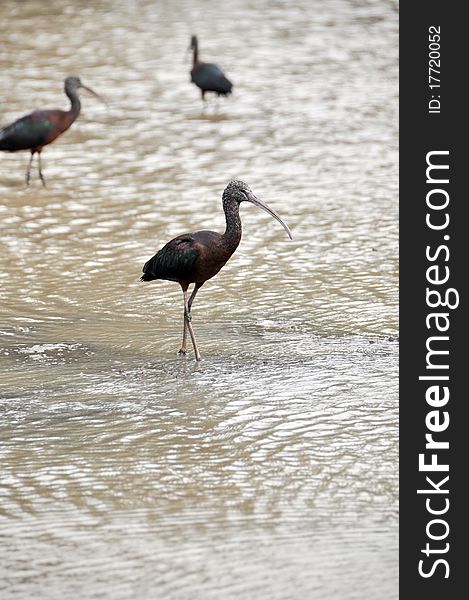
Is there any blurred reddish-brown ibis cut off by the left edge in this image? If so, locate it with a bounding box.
[0,77,105,186]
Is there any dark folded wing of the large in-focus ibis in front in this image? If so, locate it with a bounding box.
[141,233,199,281]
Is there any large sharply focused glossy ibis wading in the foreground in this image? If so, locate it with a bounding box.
[141,181,292,360]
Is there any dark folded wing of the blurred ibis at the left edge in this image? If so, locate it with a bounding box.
[0,111,57,152]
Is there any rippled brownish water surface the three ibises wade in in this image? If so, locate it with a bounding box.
[0,0,398,600]
